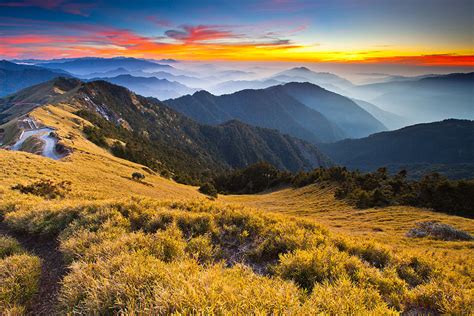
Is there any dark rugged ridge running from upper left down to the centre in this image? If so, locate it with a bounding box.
[0,78,328,182]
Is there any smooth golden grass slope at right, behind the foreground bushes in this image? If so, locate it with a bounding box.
[219,185,474,263]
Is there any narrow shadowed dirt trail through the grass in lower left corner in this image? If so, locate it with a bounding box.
[0,222,66,315]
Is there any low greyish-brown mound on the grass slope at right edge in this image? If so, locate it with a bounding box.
[407,221,474,241]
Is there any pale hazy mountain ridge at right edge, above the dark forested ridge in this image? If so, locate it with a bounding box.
[350,72,474,124]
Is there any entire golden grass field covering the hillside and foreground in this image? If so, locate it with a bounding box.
[0,105,474,315]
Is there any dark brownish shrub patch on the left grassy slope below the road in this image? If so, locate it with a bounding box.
[12,179,71,199]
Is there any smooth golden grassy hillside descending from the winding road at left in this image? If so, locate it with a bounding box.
[0,106,205,200]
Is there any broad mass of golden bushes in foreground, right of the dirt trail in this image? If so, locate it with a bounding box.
[0,198,473,315]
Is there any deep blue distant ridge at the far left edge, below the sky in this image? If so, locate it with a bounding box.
[0,60,70,97]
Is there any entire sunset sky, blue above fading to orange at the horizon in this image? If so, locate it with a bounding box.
[0,0,474,68]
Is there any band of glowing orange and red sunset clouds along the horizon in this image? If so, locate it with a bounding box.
[0,20,474,67]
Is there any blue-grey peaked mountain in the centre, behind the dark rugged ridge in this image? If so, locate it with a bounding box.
[165,83,386,143]
